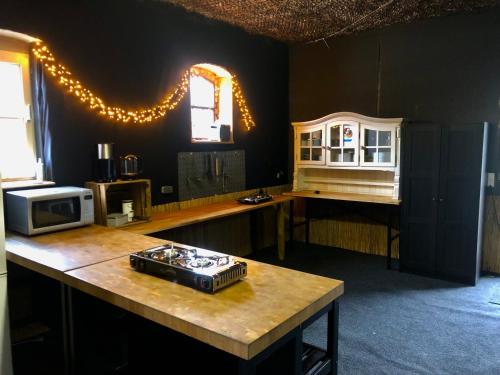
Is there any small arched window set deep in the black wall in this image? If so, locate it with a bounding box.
[189,64,233,143]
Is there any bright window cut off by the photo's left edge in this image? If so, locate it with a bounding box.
[0,50,35,180]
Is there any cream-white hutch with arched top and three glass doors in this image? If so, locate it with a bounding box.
[292,112,403,199]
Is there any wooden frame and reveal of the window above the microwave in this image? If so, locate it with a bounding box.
[0,35,37,182]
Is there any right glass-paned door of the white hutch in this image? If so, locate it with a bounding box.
[360,124,396,166]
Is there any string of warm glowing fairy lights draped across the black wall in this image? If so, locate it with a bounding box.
[33,41,255,130]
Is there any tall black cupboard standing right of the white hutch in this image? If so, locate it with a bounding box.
[400,123,487,284]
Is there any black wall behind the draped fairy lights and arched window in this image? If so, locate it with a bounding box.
[0,0,290,204]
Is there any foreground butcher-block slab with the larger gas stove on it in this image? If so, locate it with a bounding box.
[64,257,344,359]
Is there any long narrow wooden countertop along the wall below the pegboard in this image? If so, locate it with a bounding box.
[119,195,294,234]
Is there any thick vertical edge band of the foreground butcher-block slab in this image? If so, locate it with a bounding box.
[63,273,344,360]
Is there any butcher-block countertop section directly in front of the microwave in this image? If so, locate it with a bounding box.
[5,225,165,281]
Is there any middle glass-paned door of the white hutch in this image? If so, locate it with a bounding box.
[326,121,359,166]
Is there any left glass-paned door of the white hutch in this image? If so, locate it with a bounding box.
[297,125,325,164]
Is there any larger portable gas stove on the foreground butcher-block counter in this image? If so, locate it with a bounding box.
[130,243,247,293]
